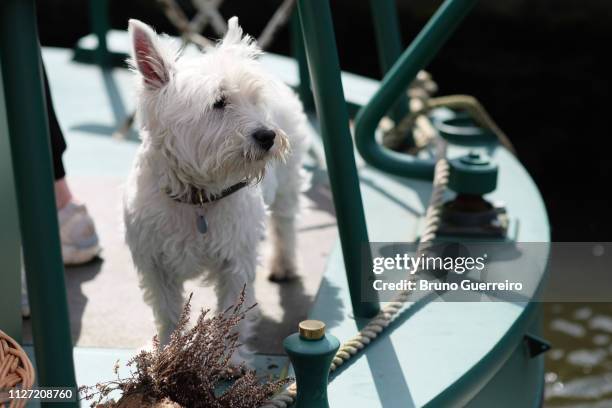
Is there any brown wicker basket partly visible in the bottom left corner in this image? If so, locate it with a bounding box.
[0,330,34,408]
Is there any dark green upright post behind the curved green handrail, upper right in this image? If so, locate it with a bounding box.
[370,0,414,138]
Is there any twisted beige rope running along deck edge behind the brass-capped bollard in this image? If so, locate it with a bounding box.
[261,138,449,408]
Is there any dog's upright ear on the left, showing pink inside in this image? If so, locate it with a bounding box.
[128,19,172,89]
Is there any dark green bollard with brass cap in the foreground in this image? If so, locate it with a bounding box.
[283,320,340,408]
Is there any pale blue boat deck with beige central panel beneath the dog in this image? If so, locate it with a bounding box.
[11,37,549,408]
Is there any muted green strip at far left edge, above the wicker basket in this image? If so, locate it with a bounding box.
[0,58,22,342]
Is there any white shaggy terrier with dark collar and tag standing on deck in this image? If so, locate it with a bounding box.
[124,17,306,360]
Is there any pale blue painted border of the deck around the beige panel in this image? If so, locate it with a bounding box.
[2,32,549,408]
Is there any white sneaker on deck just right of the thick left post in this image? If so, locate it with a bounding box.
[57,203,101,265]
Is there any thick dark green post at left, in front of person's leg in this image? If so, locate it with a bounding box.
[0,0,77,407]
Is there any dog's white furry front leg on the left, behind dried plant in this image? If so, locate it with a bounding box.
[140,266,185,344]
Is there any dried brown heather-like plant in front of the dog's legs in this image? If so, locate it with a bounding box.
[81,289,290,408]
